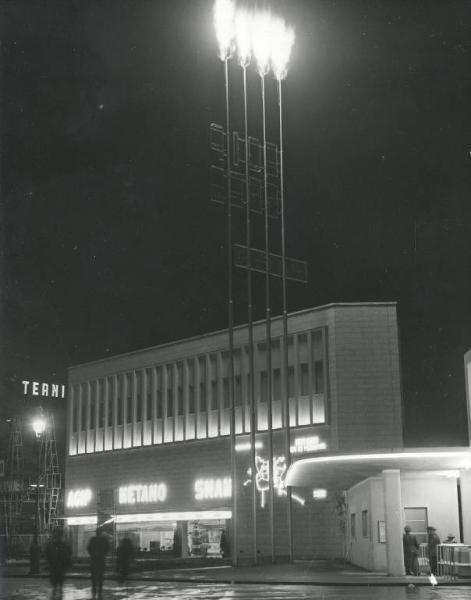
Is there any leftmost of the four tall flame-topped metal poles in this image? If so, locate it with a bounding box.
[224,57,238,566]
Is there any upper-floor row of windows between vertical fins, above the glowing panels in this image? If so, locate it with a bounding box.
[71,330,326,432]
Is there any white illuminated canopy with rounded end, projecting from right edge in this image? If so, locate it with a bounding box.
[286,447,471,489]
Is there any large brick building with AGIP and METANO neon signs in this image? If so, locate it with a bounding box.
[65,303,402,561]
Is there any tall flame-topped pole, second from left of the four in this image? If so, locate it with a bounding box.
[242,65,257,564]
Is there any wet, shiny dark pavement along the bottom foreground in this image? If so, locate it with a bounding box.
[0,577,471,600]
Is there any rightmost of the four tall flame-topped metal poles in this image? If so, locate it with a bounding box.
[278,78,293,562]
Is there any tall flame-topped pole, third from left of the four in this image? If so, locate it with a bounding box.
[260,74,275,563]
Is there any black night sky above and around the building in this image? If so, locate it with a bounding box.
[1,0,471,454]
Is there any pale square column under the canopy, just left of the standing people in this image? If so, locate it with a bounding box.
[383,469,405,575]
